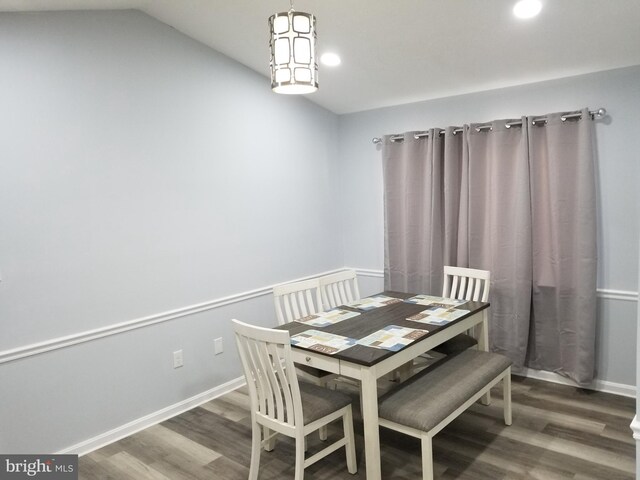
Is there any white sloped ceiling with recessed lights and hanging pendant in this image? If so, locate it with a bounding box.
[0,0,640,114]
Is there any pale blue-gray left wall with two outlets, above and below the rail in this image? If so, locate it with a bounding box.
[0,11,344,452]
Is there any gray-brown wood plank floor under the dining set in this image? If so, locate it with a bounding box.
[79,376,635,480]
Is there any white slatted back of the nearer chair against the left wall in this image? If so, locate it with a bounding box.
[273,278,322,325]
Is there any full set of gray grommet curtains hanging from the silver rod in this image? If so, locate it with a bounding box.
[382,110,596,385]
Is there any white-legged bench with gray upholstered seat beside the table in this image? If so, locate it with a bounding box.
[378,350,512,480]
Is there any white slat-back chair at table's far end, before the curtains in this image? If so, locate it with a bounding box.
[433,265,491,355]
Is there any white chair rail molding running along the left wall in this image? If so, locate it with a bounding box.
[0,268,344,365]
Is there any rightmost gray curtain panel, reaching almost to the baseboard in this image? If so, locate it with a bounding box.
[527,109,597,385]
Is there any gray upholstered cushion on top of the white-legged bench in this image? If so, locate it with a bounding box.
[378,350,512,432]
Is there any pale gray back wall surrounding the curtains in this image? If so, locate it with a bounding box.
[339,67,640,385]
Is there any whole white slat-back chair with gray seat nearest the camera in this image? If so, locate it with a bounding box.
[232,319,357,480]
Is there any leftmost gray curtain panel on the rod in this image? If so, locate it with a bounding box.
[382,127,463,292]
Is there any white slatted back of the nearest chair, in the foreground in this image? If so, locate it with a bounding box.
[233,320,303,430]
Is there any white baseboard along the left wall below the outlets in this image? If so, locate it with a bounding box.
[58,377,246,455]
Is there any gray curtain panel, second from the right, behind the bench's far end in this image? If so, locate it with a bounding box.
[464,119,532,371]
